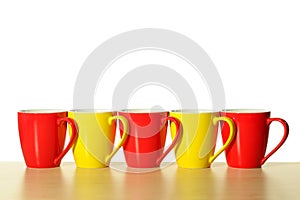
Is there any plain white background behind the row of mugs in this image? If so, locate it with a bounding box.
[0,0,300,162]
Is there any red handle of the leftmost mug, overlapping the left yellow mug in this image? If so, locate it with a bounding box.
[54,117,78,165]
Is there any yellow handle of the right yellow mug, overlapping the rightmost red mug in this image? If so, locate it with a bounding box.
[208,117,236,164]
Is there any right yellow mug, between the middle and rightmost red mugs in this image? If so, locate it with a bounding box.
[170,110,235,168]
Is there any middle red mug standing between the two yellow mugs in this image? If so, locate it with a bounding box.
[118,110,182,168]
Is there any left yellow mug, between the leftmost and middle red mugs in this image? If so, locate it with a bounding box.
[68,109,128,168]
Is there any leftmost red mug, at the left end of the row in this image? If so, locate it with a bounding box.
[18,110,78,168]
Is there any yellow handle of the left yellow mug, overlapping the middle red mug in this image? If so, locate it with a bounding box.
[105,116,128,165]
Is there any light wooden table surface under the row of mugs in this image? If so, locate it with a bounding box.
[0,162,300,200]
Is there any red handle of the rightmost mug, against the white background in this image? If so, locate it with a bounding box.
[260,118,289,165]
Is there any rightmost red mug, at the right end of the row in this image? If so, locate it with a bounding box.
[221,109,289,168]
